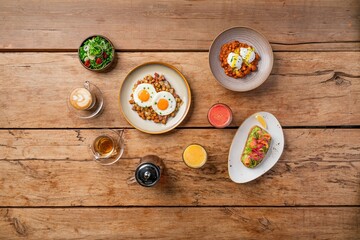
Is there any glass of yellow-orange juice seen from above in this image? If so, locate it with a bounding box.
[183,144,207,168]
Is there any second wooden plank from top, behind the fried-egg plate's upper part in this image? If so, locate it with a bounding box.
[0,52,360,128]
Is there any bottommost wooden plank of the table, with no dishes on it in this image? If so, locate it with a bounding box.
[0,207,360,239]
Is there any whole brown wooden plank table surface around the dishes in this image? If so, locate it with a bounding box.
[0,0,360,239]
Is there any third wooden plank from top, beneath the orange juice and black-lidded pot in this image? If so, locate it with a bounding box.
[0,129,360,206]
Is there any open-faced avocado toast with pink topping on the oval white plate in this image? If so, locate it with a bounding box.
[241,126,271,168]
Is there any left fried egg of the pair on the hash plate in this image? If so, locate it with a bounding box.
[133,83,156,107]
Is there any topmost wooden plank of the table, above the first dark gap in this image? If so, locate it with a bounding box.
[0,0,360,51]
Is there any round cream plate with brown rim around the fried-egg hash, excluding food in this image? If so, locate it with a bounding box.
[120,62,191,134]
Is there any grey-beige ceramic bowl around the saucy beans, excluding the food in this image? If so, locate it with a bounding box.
[209,27,273,92]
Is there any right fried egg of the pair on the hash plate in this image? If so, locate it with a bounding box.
[152,91,176,116]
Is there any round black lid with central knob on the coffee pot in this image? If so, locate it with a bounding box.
[135,163,160,187]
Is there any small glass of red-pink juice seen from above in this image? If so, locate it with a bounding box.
[208,103,232,128]
